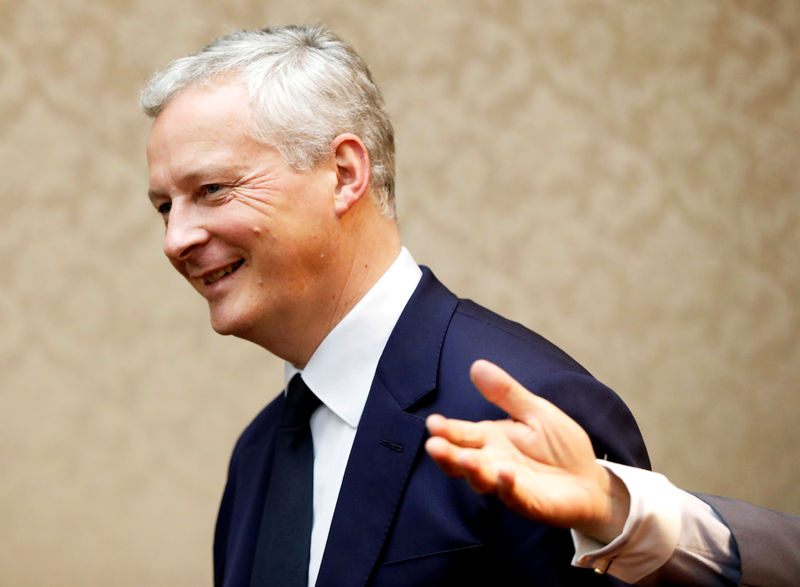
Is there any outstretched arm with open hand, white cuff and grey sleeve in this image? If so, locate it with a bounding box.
[426,361,800,587]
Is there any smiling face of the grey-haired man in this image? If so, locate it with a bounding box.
[147,84,337,344]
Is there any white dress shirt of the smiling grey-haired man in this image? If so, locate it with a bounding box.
[285,247,422,586]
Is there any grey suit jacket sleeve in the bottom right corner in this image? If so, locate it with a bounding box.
[697,494,800,587]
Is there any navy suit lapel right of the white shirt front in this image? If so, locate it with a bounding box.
[317,268,457,587]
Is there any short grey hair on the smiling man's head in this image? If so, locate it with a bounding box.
[139,25,395,218]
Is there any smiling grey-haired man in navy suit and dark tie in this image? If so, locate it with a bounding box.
[141,26,649,587]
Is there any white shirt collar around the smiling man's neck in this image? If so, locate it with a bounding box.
[284,247,422,428]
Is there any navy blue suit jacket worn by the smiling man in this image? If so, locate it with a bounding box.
[214,268,649,587]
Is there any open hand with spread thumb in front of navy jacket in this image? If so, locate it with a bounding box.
[425,360,630,542]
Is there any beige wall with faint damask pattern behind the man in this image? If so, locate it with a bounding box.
[0,0,800,586]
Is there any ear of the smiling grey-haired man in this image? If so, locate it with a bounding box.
[331,133,370,217]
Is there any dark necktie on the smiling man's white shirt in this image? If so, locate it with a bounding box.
[250,373,320,587]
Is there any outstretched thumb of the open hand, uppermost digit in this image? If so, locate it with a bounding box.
[470,359,552,421]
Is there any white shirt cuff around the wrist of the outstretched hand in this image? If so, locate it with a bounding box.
[572,460,741,586]
